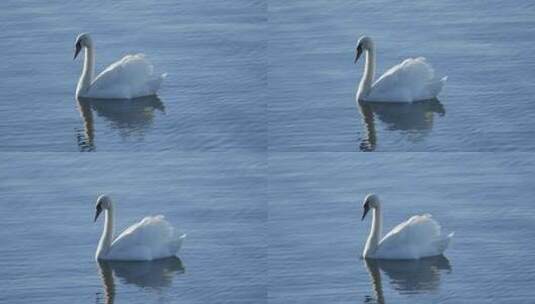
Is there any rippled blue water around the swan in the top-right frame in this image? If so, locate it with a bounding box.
[267,0,535,152]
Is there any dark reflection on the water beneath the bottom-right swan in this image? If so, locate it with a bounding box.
[364,255,451,304]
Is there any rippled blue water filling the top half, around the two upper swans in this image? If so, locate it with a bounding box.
[0,0,535,151]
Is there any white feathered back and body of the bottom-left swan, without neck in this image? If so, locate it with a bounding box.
[106,215,185,260]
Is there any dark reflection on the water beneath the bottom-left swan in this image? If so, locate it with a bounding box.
[96,257,185,304]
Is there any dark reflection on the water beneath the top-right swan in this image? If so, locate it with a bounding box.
[358,99,446,151]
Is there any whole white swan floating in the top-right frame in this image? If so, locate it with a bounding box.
[355,36,447,102]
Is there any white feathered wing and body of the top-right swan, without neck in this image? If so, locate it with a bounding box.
[366,57,446,102]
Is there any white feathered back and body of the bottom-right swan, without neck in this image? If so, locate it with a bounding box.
[374,214,453,259]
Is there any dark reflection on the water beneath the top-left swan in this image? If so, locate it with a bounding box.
[76,96,165,152]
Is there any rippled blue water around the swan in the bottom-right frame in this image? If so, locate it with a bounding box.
[268,153,535,303]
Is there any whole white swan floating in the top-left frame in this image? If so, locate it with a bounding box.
[74,33,166,99]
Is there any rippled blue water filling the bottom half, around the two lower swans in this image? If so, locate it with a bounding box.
[0,153,535,303]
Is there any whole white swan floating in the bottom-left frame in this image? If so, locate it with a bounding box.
[95,195,186,261]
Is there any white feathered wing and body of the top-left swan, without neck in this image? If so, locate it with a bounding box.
[88,54,165,98]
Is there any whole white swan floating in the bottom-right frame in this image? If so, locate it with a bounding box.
[362,194,453,259]
